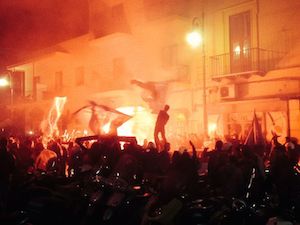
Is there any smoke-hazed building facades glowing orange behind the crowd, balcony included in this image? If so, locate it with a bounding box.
[2,0,300,146]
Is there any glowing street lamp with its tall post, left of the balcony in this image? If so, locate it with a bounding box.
[186,13,208,139]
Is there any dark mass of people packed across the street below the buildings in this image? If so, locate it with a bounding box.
[0,117,300,222]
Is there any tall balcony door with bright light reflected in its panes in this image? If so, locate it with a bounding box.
[229,11,251,73]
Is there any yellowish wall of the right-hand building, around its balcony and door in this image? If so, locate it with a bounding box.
[204,0,300,141]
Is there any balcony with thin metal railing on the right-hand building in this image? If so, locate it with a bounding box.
[210,48,285,81]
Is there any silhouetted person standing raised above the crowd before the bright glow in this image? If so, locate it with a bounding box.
[154,105,170,150]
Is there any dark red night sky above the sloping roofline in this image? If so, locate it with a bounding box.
[0,0,89,66]
